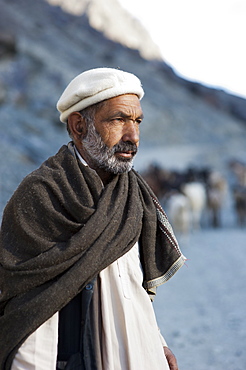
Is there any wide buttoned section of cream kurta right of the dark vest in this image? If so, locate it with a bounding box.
[100,244,169,370]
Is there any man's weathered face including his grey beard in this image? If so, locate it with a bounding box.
[82,94,143,174]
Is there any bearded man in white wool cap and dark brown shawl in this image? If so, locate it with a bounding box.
[0,68,185,370]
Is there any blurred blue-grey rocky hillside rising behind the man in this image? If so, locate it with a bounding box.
[0,0,246,217]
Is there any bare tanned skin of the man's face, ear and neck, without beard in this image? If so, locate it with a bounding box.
[68,94,143,183]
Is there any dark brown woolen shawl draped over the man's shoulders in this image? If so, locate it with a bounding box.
[0,146,185,369]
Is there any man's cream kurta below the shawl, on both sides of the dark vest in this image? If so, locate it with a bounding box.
[11,244,169,370]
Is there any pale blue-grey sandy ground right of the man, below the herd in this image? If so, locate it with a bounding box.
[154,223,246,370]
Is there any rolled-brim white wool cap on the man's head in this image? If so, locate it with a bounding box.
[56,68,144,123]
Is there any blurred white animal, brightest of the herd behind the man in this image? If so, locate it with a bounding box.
[182,182,207,230]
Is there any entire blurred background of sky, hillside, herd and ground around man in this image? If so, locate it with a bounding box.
[0,0,246,370]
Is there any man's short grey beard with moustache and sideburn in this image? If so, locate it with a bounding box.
[82,122,137,175]
